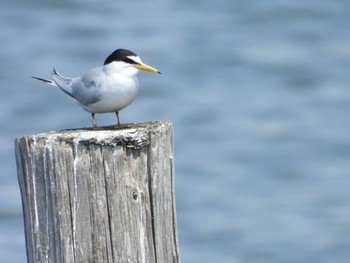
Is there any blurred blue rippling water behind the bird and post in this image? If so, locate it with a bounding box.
[0,0,350,263]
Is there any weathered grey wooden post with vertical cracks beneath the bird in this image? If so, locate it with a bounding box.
[15,122,180,263]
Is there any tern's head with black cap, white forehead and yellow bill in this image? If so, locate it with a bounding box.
[104,49,161,74]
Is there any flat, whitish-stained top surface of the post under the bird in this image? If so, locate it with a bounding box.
[17,121,172,149]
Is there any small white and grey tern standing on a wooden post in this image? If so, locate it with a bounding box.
[32,48,161,129]
